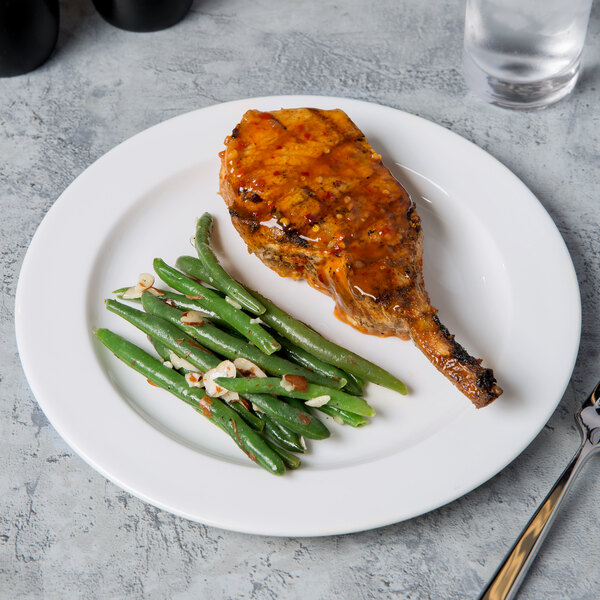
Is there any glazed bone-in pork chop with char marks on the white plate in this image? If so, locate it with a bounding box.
[220,108,502,407]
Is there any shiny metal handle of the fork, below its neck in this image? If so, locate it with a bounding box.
[479,440,594,600]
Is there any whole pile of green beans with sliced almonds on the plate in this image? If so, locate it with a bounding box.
[94,213,406,475]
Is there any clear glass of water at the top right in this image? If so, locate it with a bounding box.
[463,0,592,109]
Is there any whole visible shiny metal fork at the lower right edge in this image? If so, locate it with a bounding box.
[479,381,600,600]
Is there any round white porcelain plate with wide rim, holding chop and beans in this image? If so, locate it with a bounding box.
[16,96,580,536]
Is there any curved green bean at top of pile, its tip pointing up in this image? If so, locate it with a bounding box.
[195,213,265,315]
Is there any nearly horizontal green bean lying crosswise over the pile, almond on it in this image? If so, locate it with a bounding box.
[215,377,375,417]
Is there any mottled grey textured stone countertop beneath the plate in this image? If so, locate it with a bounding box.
[0,0,600,600]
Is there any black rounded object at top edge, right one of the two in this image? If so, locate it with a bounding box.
[92,0,193,31]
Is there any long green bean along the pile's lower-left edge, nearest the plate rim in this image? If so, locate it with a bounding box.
[94,329,285,475]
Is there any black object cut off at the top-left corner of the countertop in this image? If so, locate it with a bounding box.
[0,0,58,77]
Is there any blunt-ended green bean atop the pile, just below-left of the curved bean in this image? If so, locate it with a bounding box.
[154,258,281,354]
